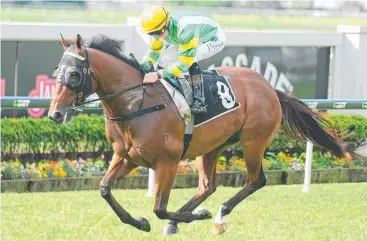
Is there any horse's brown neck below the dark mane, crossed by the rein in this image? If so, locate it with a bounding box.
[88,49,143,117]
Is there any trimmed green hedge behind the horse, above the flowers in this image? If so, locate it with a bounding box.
[1,114,367,161]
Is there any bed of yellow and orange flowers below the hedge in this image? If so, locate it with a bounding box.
[1,152,367,180]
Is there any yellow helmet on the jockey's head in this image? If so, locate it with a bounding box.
[140,7,170,33]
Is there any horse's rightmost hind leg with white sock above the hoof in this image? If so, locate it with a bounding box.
[214,132,267,235]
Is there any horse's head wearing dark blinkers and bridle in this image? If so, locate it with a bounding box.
[48,34,97,123]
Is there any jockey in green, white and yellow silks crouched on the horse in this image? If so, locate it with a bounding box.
[140,7,226,113]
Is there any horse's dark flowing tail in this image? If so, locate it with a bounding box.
[275,90,345,157]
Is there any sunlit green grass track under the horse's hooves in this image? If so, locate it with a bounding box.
[1,183,367,241]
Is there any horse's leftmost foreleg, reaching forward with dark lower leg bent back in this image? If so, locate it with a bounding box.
[100,154,150,232]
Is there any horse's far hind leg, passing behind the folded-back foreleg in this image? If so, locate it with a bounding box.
[163,146,223,235]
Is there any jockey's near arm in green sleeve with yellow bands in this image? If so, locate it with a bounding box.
[158,30,199,78]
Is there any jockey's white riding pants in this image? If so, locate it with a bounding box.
[158,28,226,68]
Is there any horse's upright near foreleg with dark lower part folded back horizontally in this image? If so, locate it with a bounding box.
[153,161,211,223]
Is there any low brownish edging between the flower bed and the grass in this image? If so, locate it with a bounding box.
[1,168,367,193]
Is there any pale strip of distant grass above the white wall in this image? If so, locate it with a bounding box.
[1,7,367,31]
